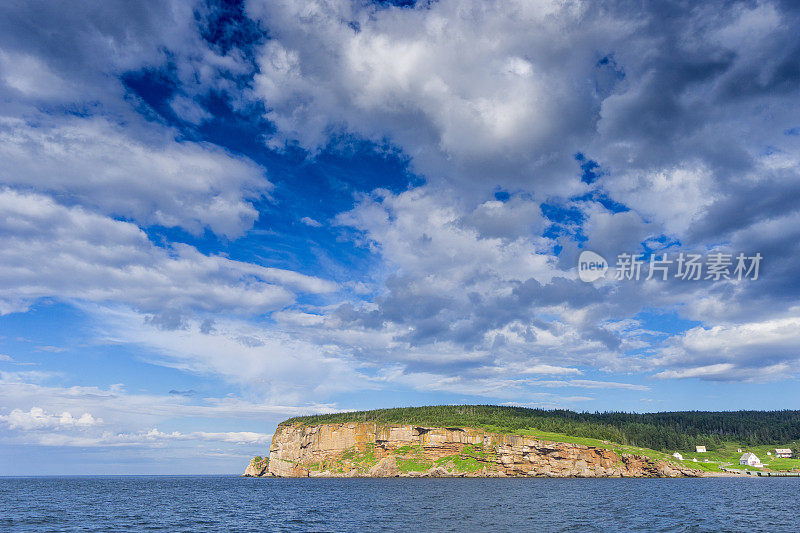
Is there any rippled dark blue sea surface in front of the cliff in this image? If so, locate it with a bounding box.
[0,476,800,532]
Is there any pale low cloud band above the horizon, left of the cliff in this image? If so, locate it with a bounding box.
[0,372,337,450]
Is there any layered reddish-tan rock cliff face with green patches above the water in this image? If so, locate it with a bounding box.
[248,422,699,477]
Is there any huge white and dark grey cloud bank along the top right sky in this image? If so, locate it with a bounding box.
[248,0,798,216]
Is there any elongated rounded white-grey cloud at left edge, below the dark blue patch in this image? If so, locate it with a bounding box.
[0,115,272,237]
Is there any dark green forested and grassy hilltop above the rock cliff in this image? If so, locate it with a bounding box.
[281,405,800,458]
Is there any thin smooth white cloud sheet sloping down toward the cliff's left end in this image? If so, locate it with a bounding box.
[92,307,375,402]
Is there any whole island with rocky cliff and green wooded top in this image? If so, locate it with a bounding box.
[244,406,800,478]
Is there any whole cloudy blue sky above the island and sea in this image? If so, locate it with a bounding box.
[0,0,800,475]
